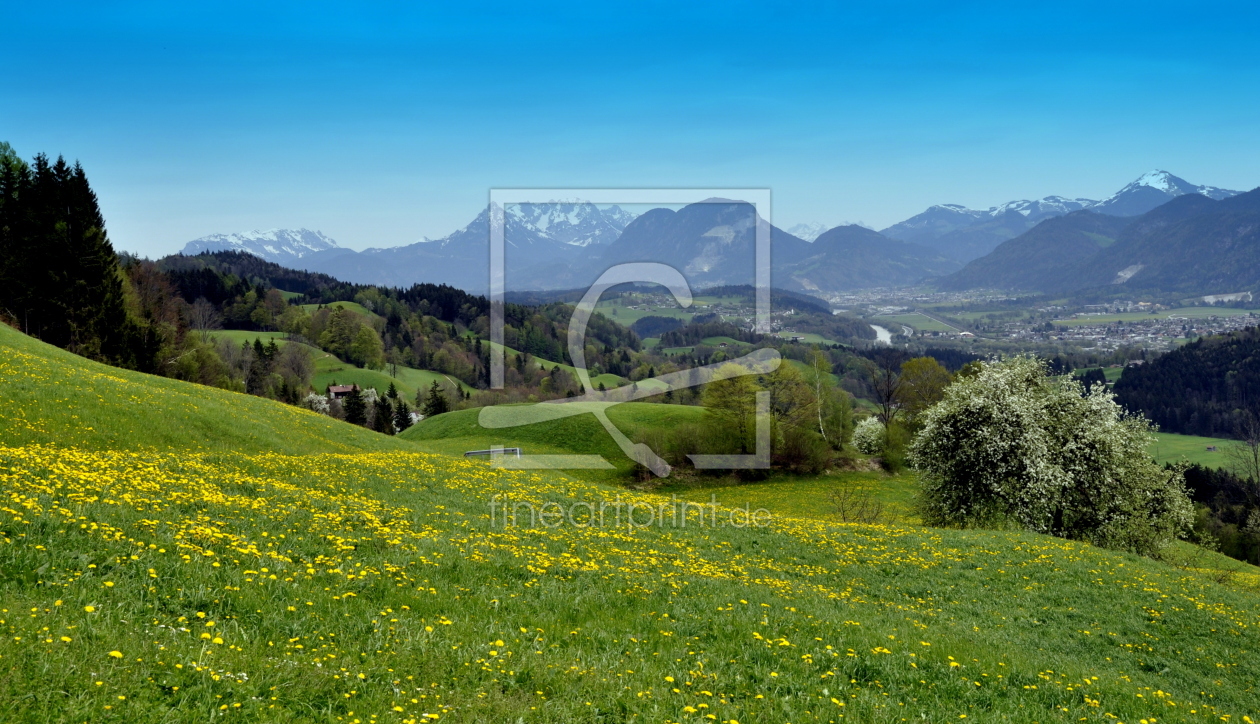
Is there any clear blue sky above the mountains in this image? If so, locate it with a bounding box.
[0,3,1260,256]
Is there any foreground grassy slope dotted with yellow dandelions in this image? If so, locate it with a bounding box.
[0,330,1260,723]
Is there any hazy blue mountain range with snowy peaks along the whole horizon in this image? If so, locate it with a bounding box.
[183,171,1237,293]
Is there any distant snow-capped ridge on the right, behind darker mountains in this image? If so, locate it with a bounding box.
[882,170,1239,262]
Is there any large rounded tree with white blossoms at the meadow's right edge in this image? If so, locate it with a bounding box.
[910,356,1192,555]
